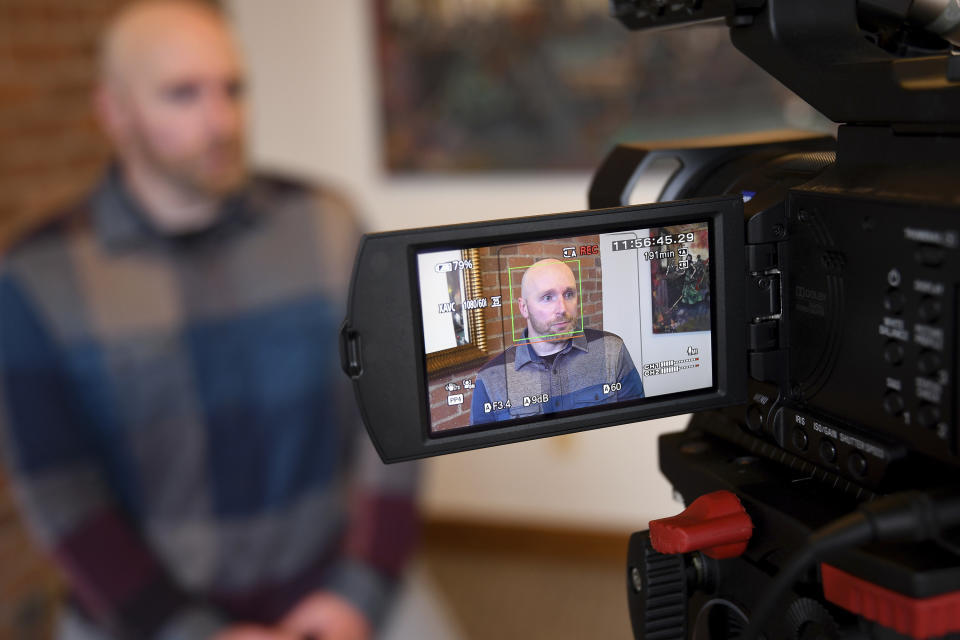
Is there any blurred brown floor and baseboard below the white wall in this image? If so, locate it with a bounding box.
[421,528,633,640]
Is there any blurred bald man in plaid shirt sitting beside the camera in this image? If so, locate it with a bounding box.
[0,0,416,640]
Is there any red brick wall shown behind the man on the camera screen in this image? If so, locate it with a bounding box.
[429,235,603,431]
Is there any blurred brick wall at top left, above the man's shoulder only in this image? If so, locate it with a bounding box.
[0,0,137,250]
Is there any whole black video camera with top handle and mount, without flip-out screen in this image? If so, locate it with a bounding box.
[604,0,960,638]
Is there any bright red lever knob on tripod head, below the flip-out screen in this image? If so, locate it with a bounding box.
[650,491,753,559]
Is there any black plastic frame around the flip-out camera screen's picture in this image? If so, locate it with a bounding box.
[345,196,747,462]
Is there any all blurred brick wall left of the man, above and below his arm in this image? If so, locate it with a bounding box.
[0,0,139,640]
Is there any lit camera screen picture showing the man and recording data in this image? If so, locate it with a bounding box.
[417,222,714,435]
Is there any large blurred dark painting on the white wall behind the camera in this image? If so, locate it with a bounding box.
[370,0,830,173]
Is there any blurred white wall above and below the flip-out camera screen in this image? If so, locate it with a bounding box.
[227,0,686,530]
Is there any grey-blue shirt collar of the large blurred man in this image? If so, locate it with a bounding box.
[92,164,256,249]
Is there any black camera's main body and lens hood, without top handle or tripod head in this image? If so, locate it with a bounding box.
[591,126,960,489]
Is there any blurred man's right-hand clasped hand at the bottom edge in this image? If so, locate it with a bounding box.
[278,591,372,640]
